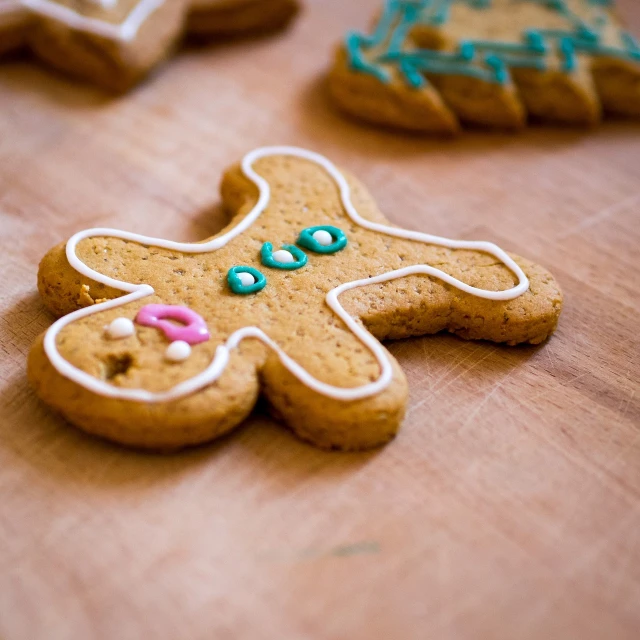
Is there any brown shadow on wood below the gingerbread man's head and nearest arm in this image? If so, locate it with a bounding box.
[0,372,377,494]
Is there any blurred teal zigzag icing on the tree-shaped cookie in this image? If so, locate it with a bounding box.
[345,0,640,89]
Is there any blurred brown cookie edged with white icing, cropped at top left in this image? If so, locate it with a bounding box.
[0,0,298,91]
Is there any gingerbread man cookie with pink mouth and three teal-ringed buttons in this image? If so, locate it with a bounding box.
[28,147,562,450]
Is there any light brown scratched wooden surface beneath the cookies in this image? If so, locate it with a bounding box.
[0,0,640,640]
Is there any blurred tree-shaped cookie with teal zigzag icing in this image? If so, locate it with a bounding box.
[330,0,640,134]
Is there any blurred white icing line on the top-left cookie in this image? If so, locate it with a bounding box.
[0,0,165,42]
